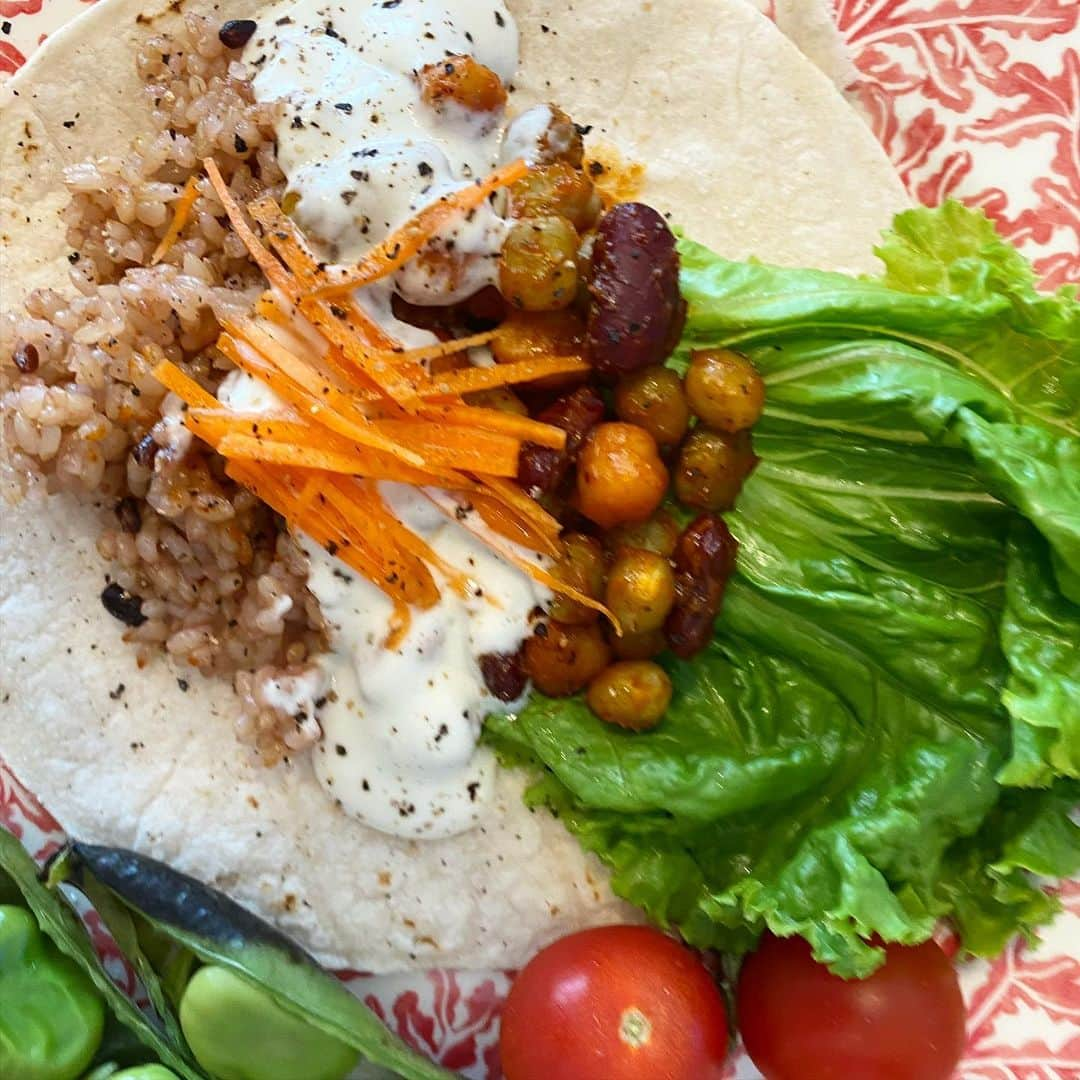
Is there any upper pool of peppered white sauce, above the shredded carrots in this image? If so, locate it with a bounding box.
[244,0,517,305]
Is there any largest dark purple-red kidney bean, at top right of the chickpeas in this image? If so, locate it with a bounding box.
[588,203,679,376]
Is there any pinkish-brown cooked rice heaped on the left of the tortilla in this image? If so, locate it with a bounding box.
[0,16,325,761]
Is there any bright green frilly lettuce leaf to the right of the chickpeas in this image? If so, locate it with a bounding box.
[487,203,1080,975]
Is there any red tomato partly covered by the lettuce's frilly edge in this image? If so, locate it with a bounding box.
[737,936,964,1080]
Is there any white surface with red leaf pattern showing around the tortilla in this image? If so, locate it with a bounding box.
[0,0,1080,1080]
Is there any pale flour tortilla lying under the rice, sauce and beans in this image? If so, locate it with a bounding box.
[0,0,905,972]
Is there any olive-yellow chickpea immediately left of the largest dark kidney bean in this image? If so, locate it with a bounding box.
[499,214,578,311]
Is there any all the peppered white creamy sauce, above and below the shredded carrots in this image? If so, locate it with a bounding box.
[238,0,551,837]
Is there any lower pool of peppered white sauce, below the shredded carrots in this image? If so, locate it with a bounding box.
[302,484,551,837]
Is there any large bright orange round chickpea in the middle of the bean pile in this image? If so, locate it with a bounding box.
[578,423,667,529]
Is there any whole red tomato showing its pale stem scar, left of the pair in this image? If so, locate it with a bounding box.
[499,927,728,1080]
